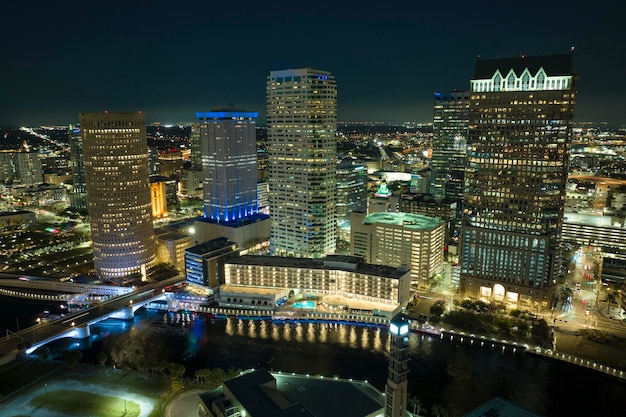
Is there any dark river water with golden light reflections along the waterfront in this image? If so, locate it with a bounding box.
[0,298,626,416]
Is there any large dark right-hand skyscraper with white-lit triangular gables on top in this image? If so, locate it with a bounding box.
[460,55,578,308]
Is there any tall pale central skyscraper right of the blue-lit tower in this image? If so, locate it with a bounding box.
[267,68,337,258]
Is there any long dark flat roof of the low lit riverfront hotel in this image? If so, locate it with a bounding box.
[227,255,408,279]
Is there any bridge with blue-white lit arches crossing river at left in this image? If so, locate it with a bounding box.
[0,276,182,365]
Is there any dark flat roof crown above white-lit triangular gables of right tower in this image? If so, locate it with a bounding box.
[472,54,574,80]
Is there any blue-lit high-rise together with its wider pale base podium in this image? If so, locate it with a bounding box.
[191,109,269,253]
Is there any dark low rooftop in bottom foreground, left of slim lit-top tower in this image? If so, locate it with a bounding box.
[201,369,384,417]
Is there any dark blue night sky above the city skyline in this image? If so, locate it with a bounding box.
[0,0,626,126]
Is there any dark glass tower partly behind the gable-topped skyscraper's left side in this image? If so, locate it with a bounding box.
[430,91,470,202]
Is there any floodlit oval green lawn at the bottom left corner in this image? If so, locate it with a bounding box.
[30,390,140,417]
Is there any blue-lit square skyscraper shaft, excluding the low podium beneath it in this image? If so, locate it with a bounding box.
[196,109,258,222]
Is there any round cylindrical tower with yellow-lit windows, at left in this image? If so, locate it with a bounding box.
[80,112,155,280]
